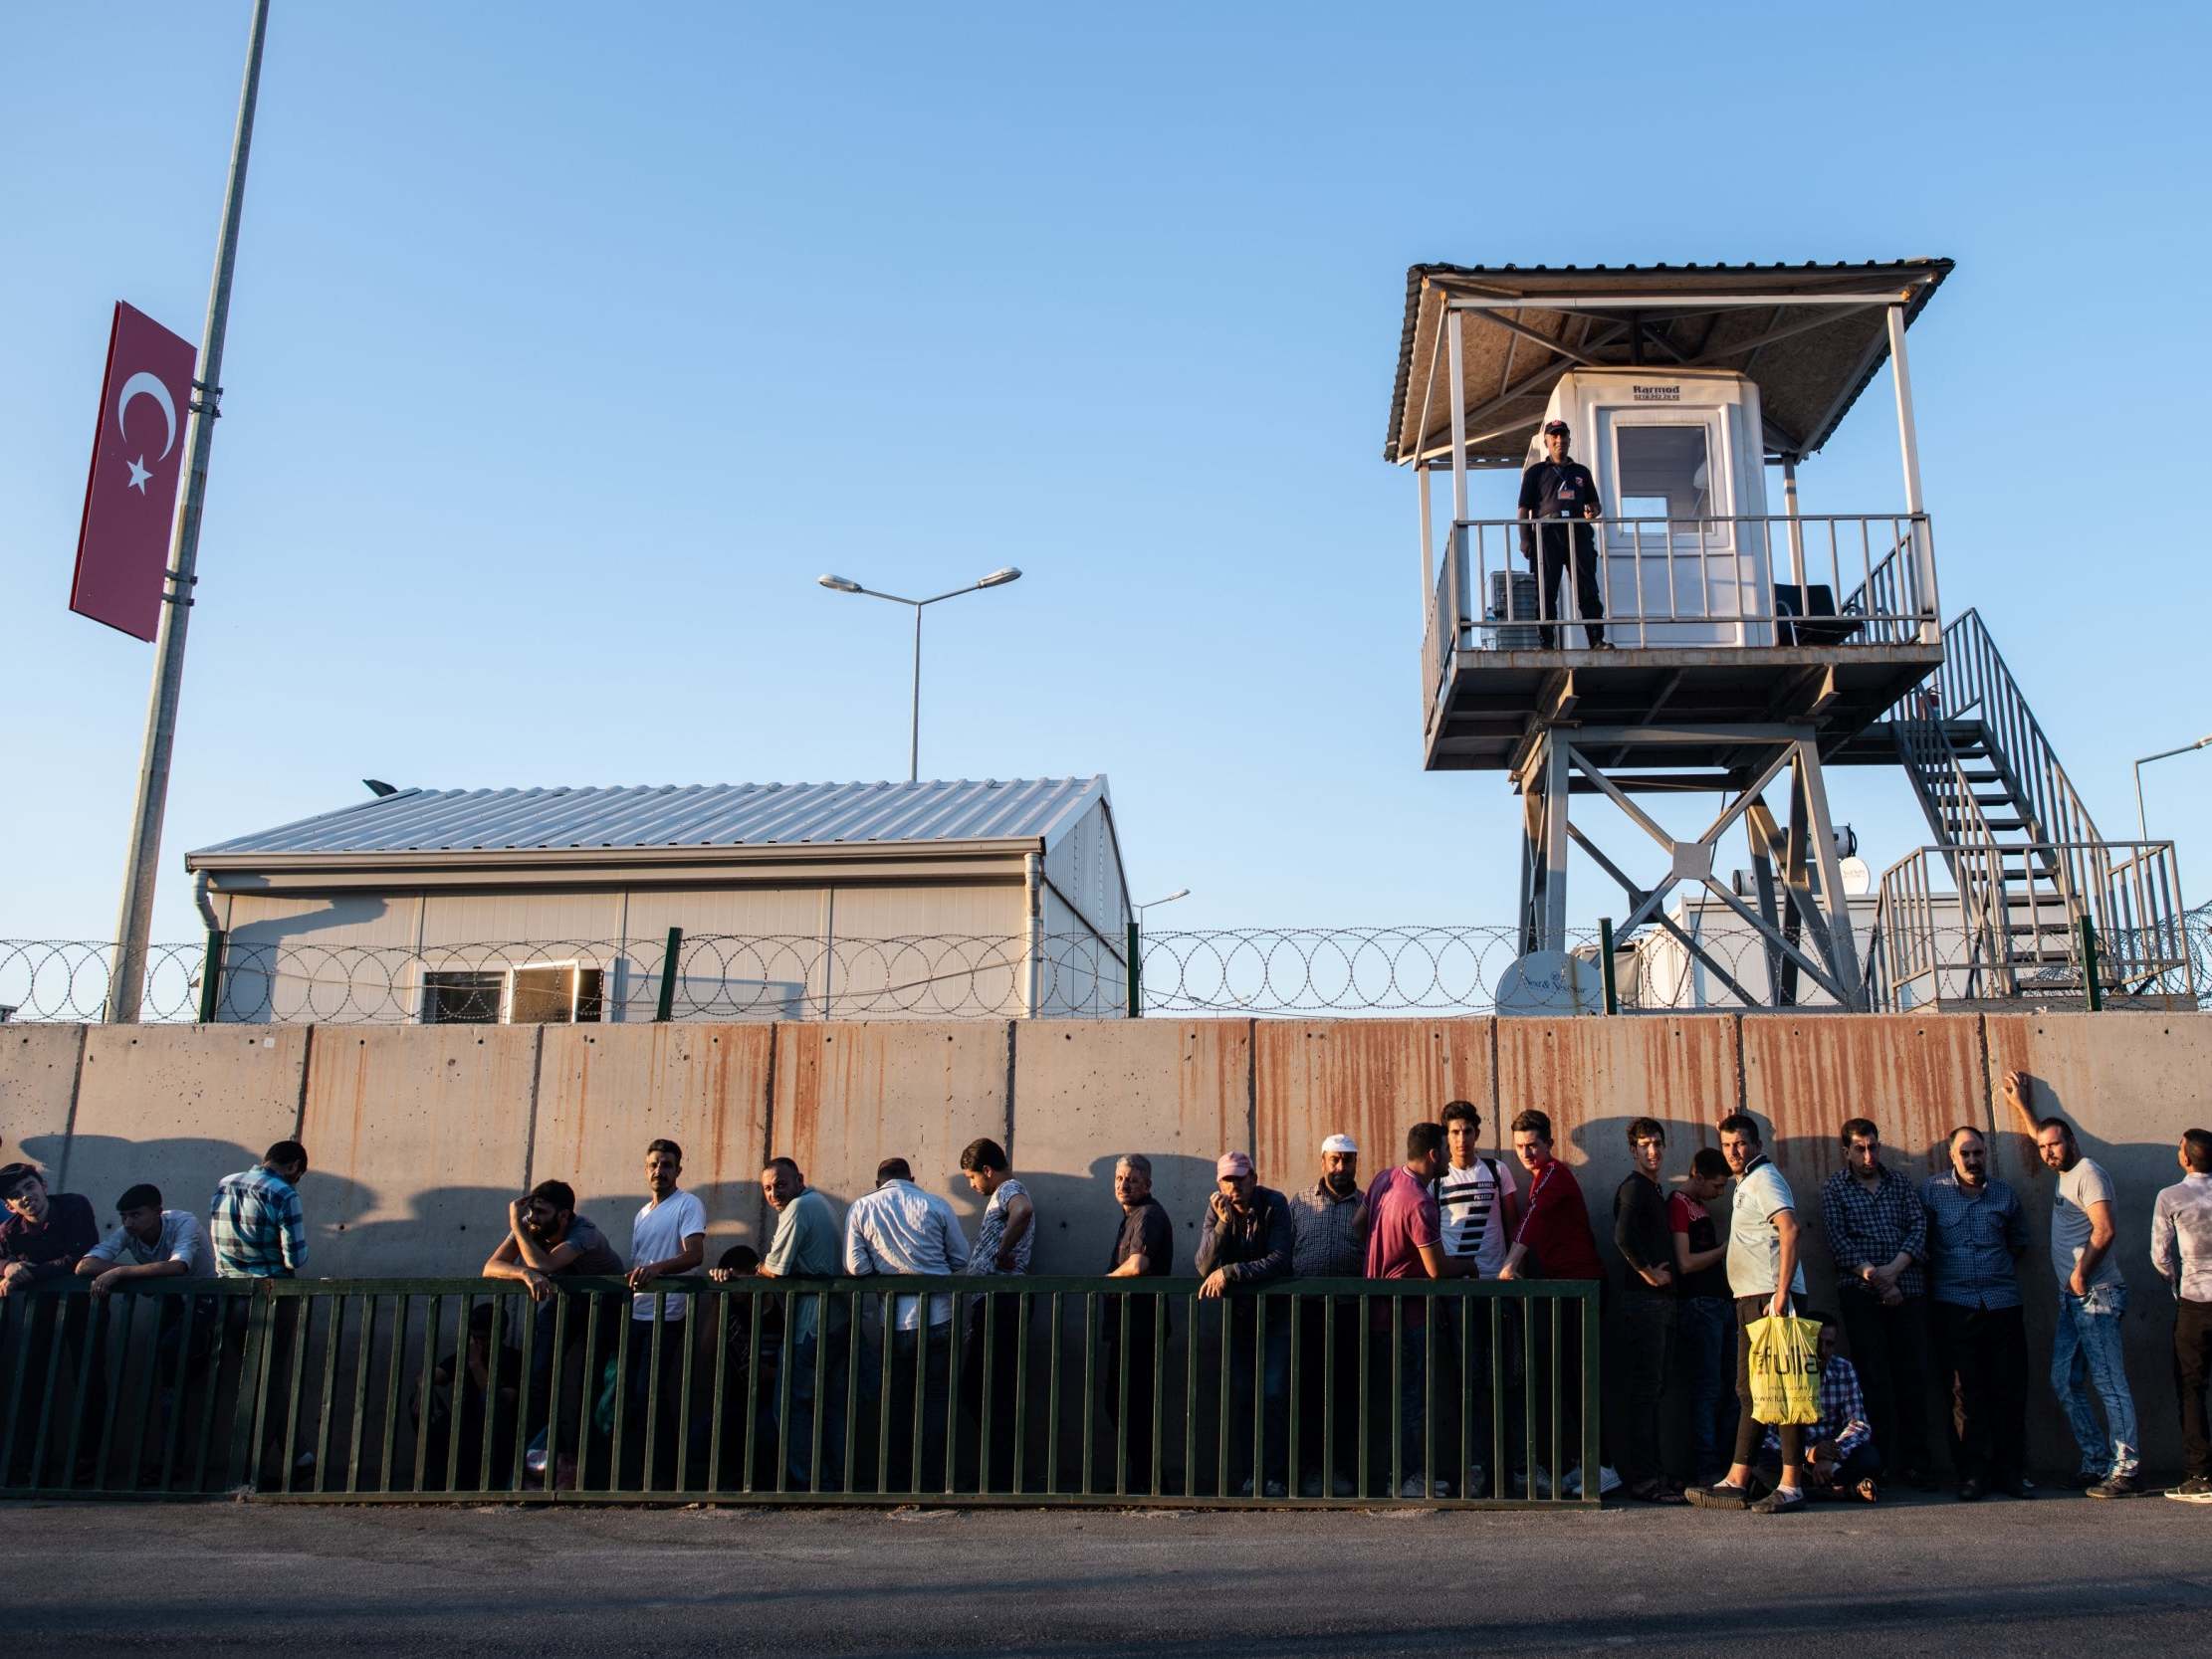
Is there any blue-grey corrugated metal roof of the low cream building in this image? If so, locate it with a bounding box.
[186,774,1106,870]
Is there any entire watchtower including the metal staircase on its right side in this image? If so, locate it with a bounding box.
[1383,259,2194,1009]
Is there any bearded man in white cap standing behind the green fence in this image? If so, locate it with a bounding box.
[1289,1135,1367,1498]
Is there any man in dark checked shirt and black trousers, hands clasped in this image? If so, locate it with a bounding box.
[1821,1117,1935,1491]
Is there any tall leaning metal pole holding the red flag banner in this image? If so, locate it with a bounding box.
[109,0,270,1024]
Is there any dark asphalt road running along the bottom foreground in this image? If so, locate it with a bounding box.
[0,1496,2212,1659]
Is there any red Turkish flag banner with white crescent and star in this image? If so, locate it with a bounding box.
[69,301,199,639]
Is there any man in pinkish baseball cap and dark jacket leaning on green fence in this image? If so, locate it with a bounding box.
[1197,1152,1292,1498]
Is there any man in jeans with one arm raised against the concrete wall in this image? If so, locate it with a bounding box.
[2004,1071,2143,1498]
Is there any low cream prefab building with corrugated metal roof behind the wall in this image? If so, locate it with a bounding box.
[186,776,1130,1024]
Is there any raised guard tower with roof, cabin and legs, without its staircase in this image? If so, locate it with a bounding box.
[1385,259,1951,1006]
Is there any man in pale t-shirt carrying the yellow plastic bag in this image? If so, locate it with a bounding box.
[1687,1113,1805,1516]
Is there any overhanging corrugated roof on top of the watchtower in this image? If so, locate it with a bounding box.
[1383,259,1951,467]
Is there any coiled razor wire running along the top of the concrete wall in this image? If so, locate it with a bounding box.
[0,925,2212,1024]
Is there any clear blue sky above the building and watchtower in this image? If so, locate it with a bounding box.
[0,0,2212,937]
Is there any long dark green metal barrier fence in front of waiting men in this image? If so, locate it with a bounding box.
[0,1279,1600,1507]
